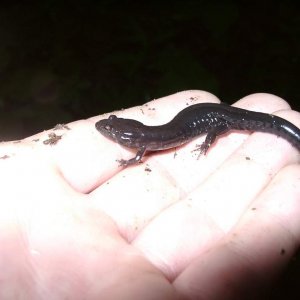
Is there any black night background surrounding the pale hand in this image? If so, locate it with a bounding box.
[0,0,300,299]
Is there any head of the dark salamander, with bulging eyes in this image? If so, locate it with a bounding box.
[95,115,145,148]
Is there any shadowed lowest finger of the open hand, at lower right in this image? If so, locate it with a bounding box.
[174,165,300,299]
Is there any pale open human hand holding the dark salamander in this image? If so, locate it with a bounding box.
[0,91,300,300]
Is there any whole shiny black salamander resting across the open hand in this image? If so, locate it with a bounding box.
[95,103,300,166]
